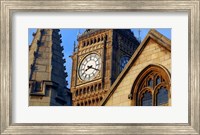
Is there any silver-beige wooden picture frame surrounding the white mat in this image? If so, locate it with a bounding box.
[0,0,200,134]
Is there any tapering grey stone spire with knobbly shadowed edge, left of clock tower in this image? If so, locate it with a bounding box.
[29,29,71,106]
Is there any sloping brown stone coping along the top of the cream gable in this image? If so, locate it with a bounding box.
[100,29,171,106]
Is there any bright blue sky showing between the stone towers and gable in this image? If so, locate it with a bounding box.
[28,28,171,87]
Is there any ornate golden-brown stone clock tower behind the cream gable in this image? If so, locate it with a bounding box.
[71,29,139,106]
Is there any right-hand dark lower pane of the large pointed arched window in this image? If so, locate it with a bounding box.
[157,87,168,105]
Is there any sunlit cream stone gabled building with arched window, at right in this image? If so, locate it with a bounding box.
[100,29,171,106]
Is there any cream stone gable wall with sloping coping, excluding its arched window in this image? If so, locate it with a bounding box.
[101,30,171,105]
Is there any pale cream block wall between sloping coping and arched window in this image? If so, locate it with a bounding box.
[105,30,171,106]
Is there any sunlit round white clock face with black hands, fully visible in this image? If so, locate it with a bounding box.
[78,53,101,81]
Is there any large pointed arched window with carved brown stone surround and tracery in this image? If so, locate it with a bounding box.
[130,65,171,106]
